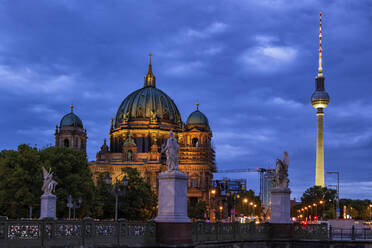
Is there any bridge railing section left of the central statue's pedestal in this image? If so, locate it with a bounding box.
[0,218,156,247]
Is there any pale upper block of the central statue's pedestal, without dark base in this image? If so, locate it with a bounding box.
[155,170,190,223]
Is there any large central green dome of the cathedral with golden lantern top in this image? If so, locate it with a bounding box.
[115,58,182,128]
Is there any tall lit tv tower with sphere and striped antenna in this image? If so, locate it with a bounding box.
[311,12,329,187]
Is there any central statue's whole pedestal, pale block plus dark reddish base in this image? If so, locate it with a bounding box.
[155,170,192,245]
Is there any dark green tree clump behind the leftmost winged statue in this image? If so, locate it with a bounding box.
[0,145,94,218]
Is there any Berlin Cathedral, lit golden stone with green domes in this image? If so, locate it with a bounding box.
[55,54,216,204]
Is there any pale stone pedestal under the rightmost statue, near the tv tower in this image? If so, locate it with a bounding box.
[270,188,292,224]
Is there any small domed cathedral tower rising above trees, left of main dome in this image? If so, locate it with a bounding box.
[54,105,88,152]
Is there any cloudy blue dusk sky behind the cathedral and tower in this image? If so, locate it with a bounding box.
[0,0,372,199]
